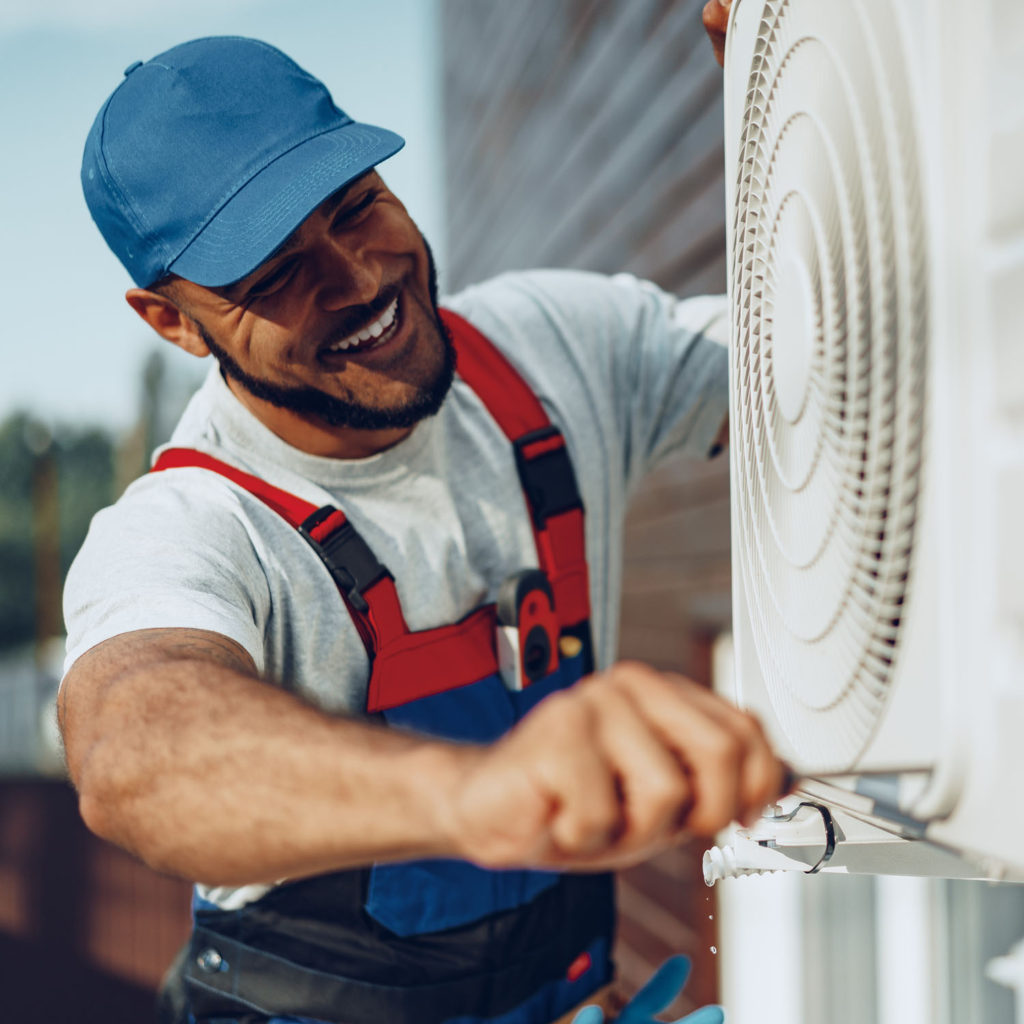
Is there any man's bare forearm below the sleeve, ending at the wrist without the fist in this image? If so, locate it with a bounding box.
[63,626,469,885]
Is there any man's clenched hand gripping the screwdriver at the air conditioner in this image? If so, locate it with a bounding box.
[446,663,783,870]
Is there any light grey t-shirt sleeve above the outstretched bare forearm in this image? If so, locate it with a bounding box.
[63,470,269,673]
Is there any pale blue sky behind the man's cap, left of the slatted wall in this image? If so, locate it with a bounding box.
[0,0,444,430]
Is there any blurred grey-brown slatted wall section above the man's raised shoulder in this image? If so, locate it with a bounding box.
[442,0,725,295]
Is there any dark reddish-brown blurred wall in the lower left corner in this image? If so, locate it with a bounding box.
[0,779,191,1024]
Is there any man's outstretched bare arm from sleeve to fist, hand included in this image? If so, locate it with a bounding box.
[59,629,782,885]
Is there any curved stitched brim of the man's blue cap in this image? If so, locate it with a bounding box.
[168,121,406,288]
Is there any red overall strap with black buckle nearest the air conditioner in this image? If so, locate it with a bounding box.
[441,309,590,627]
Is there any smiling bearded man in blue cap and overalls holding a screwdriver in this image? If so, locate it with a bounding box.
[59,22,770,1024]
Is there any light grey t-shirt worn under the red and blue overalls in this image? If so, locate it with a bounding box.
[65,270,727,905]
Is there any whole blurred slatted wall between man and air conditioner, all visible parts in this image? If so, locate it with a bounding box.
[441,0,729,1009]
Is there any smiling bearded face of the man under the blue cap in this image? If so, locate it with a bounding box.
[169,171,455,447]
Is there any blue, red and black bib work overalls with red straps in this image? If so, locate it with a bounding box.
[154,310,614,1024]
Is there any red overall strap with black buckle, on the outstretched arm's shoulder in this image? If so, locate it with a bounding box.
[151,449,409,663]
